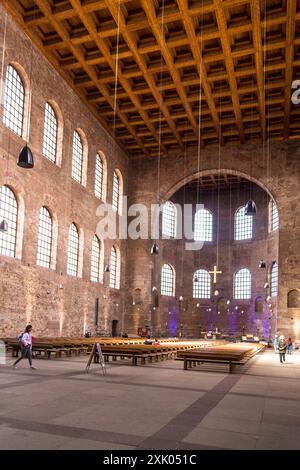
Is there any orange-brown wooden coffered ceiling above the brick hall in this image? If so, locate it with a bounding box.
[0,0,300,156]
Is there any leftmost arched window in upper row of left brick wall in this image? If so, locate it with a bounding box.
[3,65,25,136]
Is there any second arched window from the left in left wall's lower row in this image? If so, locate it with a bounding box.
[36,207,53,268]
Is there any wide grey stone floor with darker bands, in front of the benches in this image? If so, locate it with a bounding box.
[0,350,300,450]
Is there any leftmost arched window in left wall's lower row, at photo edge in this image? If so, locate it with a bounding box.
[0,185,18,257]
